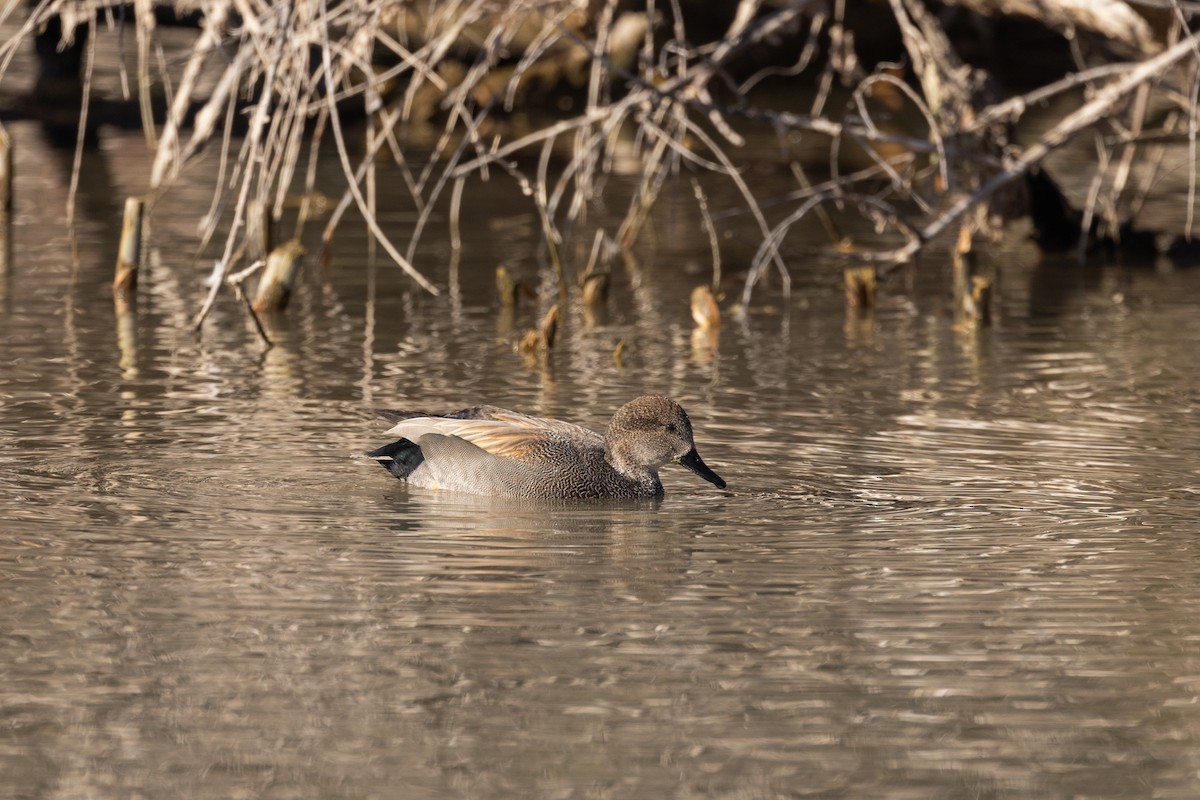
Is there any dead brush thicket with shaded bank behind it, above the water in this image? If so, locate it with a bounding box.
[0,0,1200,326]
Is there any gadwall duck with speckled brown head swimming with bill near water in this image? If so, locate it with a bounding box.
[366,395,725,499]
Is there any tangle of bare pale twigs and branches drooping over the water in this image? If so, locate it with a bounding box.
[9,0,1200,325]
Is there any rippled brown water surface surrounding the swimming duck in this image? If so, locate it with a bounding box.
[0,120,1200,800]
